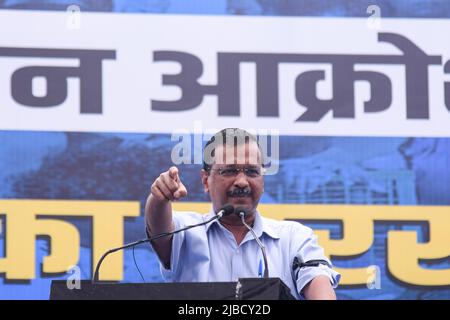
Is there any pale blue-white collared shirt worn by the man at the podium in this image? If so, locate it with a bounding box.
[152,211,340,299]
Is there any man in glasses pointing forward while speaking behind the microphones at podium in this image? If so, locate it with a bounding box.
[145,129,340,299]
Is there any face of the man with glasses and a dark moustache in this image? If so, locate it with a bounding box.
[201,141,264,212]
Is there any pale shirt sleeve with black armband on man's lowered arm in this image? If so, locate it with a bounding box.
[291,224,341,298]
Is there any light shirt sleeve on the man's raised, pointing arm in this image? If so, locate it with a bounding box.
[147,213,185,282]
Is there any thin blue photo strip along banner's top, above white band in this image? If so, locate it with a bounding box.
[0,0,450,18]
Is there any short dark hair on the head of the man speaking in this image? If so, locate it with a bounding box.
[203,128,263,172]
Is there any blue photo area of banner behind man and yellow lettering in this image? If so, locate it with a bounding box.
[0,132,450,299]
